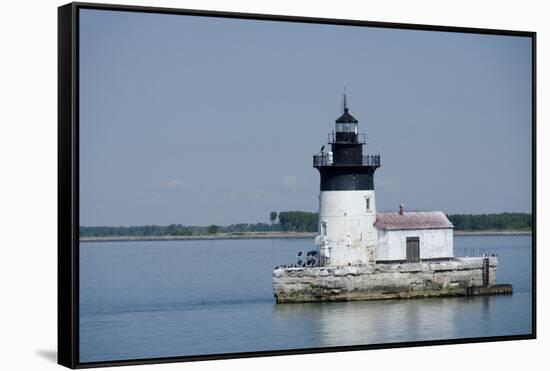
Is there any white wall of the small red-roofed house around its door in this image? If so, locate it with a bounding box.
[376,228,453,260]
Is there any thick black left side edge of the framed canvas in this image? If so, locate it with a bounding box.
[57,4,79,368]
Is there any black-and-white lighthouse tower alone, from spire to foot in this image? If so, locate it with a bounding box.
[313,93,380,266]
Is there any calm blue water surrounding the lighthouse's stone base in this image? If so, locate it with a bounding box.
[80,236,531,362]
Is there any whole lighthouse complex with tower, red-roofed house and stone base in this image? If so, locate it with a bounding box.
[273,91,513,303]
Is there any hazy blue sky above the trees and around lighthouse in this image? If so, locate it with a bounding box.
[80,10,532,225]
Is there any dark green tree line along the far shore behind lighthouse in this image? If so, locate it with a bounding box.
[80,211,532,237]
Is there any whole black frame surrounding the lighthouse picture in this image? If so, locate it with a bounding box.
[58,3,537,368]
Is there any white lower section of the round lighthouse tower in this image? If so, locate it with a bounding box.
[319,191,378,265]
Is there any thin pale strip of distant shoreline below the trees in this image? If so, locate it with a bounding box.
[80,230,532,242]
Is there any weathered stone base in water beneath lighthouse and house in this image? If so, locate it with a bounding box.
[273,257,512,303]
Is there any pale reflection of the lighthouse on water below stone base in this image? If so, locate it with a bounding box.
[274,296,496,347]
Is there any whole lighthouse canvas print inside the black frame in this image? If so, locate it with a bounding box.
[78,9,534,363]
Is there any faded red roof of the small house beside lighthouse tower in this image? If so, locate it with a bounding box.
[374,211,454,230]
